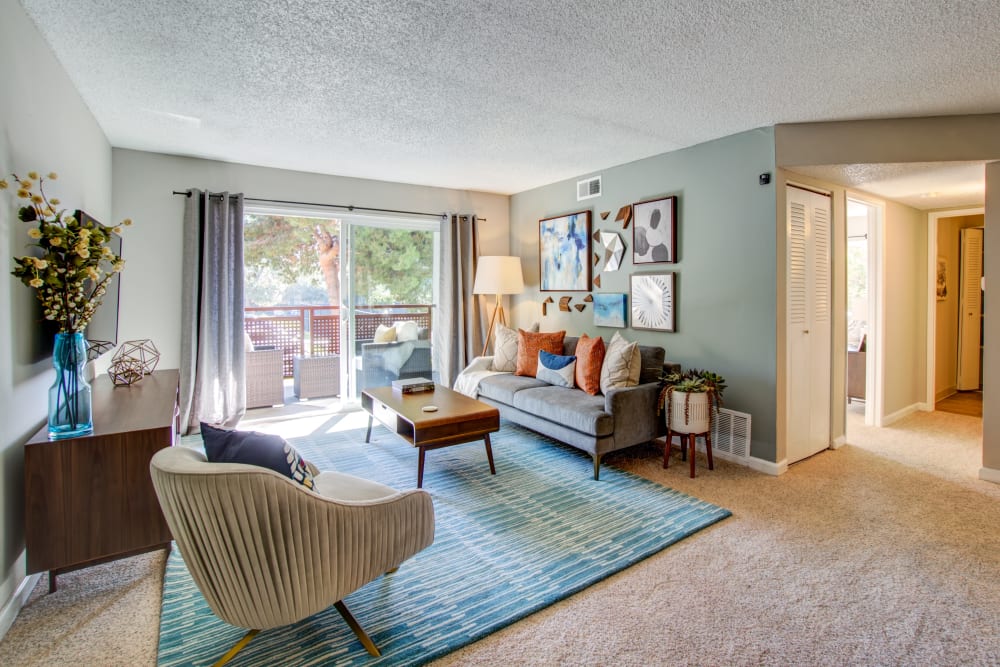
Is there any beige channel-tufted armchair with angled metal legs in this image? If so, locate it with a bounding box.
[150,446,434,664]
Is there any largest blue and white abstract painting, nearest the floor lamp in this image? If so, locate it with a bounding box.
[538,211,590,292]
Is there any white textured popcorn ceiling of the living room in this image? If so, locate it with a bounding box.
[15,0,1000,193]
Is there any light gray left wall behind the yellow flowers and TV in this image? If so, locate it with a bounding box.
[0,0,111,634]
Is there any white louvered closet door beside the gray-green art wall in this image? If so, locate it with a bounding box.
[786,186,832,463]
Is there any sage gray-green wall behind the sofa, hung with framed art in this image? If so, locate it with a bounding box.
[510,128,776,461]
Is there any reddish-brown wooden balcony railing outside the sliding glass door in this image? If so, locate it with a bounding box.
[243,304,432,377]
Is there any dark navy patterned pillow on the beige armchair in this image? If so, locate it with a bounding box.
[201,422,315,489]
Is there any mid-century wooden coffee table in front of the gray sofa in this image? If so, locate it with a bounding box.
[361,385,500,489]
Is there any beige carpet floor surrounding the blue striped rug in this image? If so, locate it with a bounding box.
[0,410,1000,665]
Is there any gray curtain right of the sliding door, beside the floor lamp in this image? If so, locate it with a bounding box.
[434,215,484,387]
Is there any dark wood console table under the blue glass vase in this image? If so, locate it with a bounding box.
[24,370,179,592]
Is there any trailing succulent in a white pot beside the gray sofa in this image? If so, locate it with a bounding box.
[657,368,726,433]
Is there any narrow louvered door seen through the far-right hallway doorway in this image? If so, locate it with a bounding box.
[958,227,983,391]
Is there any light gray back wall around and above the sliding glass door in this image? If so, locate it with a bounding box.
[112,148,509,368]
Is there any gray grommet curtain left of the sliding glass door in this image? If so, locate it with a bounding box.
[180,189,246,433]
